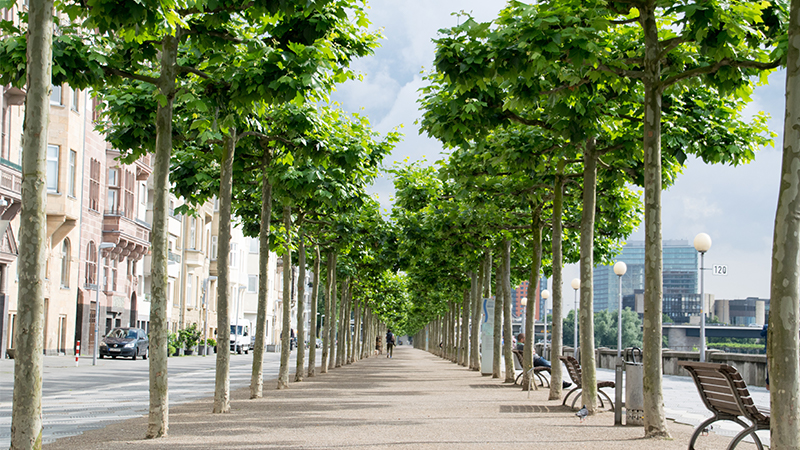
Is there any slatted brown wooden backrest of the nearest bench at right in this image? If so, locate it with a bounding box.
[678,361,769,423]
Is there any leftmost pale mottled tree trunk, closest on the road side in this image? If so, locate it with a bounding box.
[11,0,52,449]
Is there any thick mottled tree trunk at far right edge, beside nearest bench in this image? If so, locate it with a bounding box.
[767,0,800,450]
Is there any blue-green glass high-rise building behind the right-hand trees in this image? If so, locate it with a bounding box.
[593,240,699,311]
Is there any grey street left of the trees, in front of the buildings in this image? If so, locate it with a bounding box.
[0,352,310,448]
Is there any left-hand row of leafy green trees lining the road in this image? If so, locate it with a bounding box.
[6,0,416,449]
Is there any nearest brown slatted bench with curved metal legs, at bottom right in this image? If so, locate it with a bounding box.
[678,361,769,450]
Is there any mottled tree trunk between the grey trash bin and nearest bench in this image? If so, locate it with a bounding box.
[639,0,669,437]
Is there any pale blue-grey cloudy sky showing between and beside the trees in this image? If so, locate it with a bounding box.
[334,0,785,299]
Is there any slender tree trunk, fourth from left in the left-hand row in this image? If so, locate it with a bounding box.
[250,154,272,398]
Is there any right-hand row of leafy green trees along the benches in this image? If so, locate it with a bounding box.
[395,0,800,448]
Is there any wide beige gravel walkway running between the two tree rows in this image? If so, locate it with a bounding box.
[45,346,754,450]
